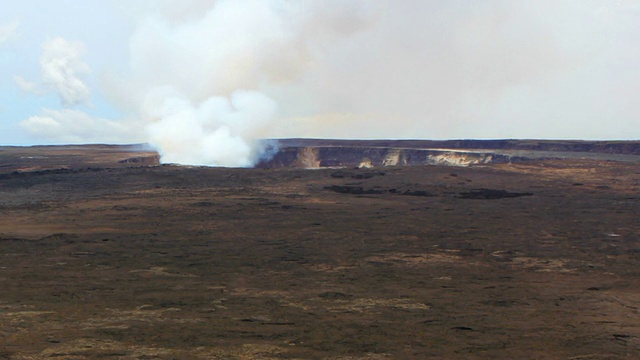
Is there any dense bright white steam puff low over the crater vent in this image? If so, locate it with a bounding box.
[144,87,276,167]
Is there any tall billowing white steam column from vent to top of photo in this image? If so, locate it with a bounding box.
[130,0,364,166]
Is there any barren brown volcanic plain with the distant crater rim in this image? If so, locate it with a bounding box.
[0,140,640,360]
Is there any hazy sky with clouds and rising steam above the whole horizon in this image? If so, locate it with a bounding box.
[0,0,640,166]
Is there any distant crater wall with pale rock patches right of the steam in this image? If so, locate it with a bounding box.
[256,139,640,169]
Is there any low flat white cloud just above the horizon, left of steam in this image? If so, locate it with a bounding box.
[20,109,144,144]
